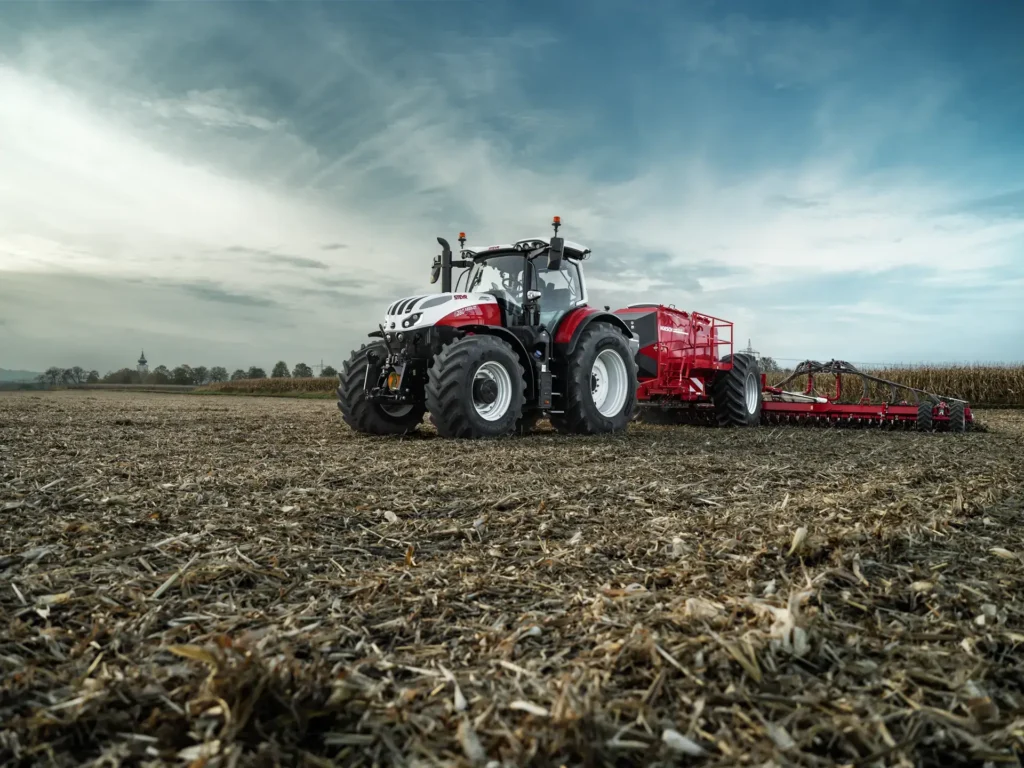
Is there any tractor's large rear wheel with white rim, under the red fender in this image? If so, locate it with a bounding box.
[551,323,637,434]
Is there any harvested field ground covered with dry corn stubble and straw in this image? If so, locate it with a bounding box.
[0,392,1024,768]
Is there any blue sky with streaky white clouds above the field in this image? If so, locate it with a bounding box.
[0,0,1024,373]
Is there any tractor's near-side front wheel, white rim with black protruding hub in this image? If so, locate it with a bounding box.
[426,334,526,438]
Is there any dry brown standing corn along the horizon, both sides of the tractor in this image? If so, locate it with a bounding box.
[197,365,1024,407]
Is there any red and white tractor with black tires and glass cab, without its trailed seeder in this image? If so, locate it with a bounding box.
[338,216,639,438]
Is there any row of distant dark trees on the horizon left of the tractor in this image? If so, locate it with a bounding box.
[36,360,338,387]
